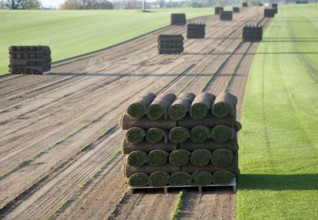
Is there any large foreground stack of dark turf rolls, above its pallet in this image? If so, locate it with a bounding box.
[120,92,241,187]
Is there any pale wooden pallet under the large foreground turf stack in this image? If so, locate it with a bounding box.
[129,178,236,194]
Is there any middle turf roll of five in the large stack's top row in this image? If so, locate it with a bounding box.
[168,93,195,120]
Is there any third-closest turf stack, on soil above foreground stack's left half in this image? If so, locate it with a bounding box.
[158,34,184,54]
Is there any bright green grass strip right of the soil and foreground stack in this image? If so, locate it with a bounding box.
[237,4,318,220]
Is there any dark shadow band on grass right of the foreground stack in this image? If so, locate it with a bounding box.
[238,174,318,190]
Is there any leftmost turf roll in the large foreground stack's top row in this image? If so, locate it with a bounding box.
[127,92,156,118]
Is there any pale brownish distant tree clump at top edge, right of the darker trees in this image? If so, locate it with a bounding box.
[60,0,114,9]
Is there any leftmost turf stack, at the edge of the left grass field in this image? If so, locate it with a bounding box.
[9,46,51,74]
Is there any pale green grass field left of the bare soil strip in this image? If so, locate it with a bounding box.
[0,8,214,74]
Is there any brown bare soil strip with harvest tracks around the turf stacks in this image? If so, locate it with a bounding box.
[0,7,271,219]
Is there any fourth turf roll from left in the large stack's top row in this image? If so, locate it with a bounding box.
[190,92,215,119]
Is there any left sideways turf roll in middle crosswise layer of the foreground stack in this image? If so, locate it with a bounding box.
[121,139,177,154]
